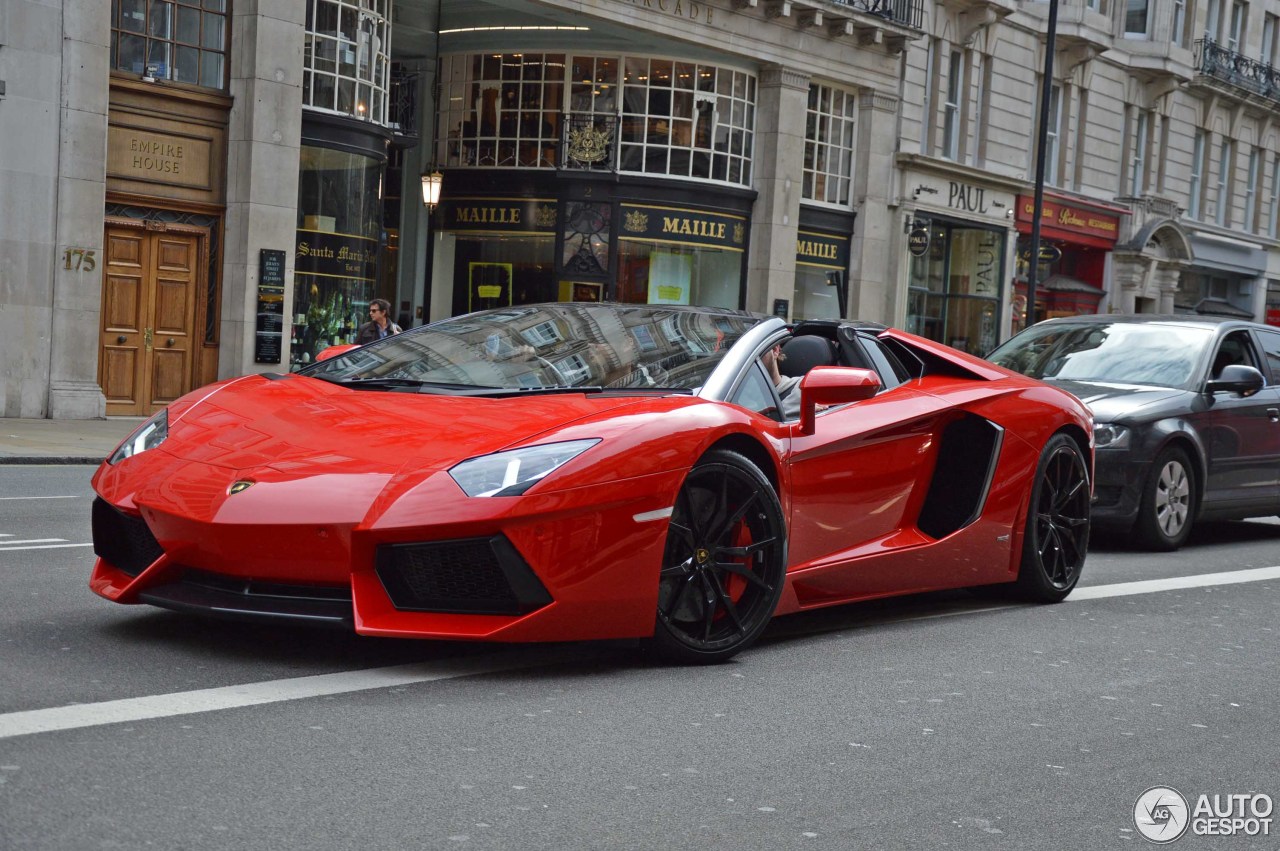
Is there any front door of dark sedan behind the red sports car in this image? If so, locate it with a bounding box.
[1192,329,1280,506]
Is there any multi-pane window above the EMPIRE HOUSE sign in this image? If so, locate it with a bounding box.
[111,0,228,88]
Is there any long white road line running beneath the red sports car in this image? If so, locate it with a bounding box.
[0,566,1280,738]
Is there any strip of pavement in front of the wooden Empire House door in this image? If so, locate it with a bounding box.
[0,417,143,465]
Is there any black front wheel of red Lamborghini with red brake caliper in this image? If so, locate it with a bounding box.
[653,449,787,664]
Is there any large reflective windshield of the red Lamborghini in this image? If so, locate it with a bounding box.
[302,303,763,392]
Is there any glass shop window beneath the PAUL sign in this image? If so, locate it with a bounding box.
[906,220,1005,356]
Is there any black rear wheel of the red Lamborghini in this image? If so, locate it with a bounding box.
[1015,434,1091,603]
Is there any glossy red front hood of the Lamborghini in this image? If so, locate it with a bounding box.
[161,375,650,476]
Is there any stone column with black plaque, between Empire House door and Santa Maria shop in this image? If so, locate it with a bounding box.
[218,0,307,378]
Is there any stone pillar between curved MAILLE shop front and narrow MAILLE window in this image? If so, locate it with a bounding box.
[746,65,809,314]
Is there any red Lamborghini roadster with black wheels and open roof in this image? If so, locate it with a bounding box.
[91,303,1093,662]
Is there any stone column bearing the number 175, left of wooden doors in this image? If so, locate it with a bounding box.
[46,0,111,420]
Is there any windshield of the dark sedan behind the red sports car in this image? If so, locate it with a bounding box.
[987,322,1213,388]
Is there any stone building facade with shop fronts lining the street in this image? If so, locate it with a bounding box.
[0,0,1280,417]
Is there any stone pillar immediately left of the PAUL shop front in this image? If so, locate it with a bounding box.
[849,91,909,325]
